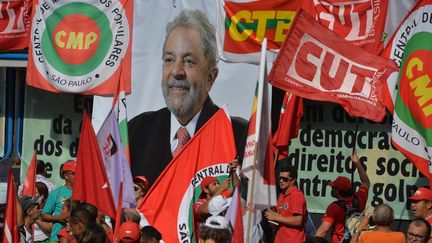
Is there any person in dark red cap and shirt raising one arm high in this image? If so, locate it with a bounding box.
[316,151,370,242]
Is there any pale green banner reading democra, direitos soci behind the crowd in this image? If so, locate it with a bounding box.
[288,100,428,219]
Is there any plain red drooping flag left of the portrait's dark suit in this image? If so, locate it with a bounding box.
[72,112,116,218]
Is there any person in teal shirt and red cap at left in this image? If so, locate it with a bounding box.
[41,160,76,241]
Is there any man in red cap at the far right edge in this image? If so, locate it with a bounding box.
[408,187,432,225]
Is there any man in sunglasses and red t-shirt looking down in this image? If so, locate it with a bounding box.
[265,166,306,243]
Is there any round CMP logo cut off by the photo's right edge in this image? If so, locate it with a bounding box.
[393,5,432,129]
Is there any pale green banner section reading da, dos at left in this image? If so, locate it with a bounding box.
[20,86,91,185]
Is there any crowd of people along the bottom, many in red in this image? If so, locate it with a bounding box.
[0,153,432,243]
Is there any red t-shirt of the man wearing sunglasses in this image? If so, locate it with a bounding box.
[274,187,306,243]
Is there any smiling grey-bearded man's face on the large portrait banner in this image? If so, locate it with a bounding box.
[162,27,217,123]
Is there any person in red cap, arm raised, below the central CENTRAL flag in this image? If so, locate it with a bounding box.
[192,160,240,241]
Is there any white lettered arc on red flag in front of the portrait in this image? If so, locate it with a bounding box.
[177,163,231,243]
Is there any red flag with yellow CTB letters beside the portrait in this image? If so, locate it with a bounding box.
[217,0,302,64]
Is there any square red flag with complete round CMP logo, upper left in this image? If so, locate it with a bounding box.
[27,0,133,95]
